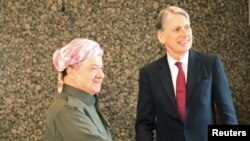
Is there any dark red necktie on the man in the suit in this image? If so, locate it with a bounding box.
[175,62,186,122]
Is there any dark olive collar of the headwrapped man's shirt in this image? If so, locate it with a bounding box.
[62,84,96,105]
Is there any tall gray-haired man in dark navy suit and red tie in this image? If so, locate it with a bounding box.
[135,6,238,141]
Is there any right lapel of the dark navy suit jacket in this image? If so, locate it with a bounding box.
[186,50,201,103]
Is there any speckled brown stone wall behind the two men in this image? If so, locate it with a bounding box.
[0,0,250,141]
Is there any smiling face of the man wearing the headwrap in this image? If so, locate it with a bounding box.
[69,56,104,95]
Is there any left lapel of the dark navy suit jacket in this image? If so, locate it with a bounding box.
[158,56,176,107]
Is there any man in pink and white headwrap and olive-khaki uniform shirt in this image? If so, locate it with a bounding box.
[44,38,112,141]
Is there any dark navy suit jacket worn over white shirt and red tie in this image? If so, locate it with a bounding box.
[135,49,238,141]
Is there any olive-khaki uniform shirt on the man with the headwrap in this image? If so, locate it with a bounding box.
[44,84,112,141]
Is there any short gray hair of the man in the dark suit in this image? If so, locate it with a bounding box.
[155,6,190,31]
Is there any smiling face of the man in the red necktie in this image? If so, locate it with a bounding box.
[157,13,193,60]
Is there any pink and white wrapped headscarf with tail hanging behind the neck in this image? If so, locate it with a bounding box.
[53,38,103,93]
